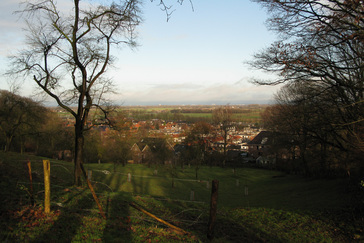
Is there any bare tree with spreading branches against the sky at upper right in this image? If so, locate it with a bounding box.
[250,0,364,165]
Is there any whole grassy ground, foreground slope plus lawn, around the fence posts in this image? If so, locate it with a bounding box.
[0,153,364,242]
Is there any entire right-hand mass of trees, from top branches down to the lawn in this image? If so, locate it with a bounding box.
[251,0,364,176]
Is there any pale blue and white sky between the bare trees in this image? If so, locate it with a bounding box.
[0,0,279,106]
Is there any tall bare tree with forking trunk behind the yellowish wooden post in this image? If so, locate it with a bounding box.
[13,0,141,185]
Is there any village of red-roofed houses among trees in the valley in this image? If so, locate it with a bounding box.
[52,106,273,166]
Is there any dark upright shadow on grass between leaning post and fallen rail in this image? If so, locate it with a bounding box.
[102,193,132,242]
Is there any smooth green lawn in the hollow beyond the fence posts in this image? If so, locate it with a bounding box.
[87,164,350,210]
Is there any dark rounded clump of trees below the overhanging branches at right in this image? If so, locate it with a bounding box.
[262,83,362,175]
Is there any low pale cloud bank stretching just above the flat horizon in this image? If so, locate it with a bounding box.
[116,83,278,105]
